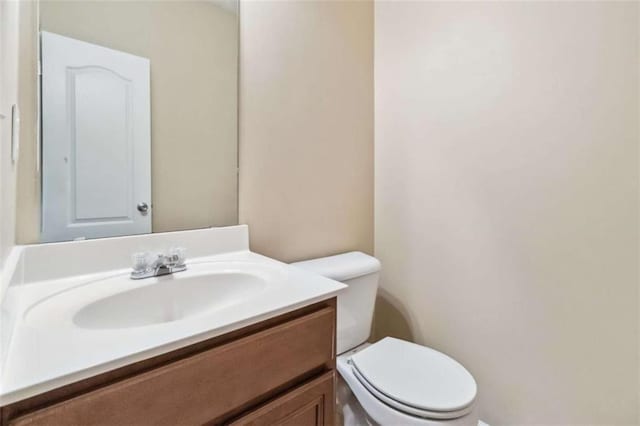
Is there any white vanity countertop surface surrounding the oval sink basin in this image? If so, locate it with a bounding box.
[0,250,345,406]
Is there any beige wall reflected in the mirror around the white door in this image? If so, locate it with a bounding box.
[18,1,238,242]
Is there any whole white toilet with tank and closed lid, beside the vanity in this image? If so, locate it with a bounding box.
[294,252,478,426]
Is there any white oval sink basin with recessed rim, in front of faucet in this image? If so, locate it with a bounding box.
[25,262,284,330]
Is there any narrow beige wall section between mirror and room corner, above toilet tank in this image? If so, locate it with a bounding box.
[240,1,373,261]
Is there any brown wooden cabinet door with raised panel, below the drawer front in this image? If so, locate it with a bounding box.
[231,371,335,426]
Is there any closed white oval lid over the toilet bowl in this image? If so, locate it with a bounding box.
[351,337,477,413]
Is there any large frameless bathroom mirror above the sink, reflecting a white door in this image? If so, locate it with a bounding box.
[19,0,238,242]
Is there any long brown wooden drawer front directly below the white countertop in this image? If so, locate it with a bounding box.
[10,307,335,426]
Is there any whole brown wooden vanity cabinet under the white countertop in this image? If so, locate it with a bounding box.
[1,298,336,426]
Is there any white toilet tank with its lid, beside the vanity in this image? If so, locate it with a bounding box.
[292,251,380,354]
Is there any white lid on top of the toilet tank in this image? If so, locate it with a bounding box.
[292,251,380,281]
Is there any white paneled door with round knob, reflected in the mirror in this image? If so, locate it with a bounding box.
[41,32,152,241]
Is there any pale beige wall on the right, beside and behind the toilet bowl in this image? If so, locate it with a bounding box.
[375,2,640,425]
